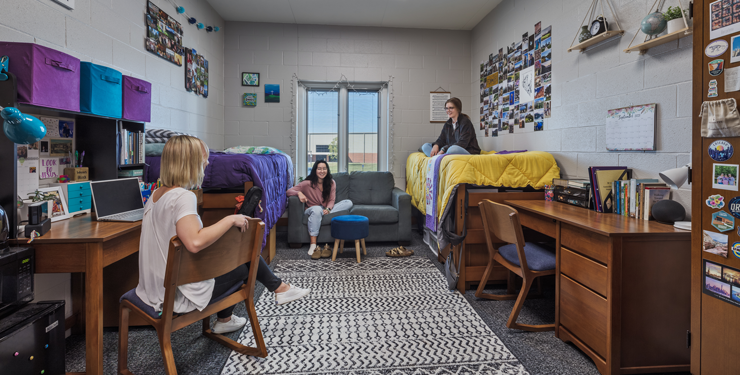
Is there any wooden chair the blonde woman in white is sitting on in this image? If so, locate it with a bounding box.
[118,219,267,374]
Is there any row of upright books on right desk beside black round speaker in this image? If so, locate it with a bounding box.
[612,178,671,220]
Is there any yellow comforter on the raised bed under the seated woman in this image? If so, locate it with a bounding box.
[406,151,560,218]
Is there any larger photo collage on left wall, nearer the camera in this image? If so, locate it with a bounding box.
[145,1,183,66]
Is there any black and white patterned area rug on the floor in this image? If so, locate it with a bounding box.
[222,256,528,375]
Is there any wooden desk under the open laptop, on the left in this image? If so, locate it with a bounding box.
[17,215,141,374]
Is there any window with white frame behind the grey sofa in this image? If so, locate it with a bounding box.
[296,82,388,176]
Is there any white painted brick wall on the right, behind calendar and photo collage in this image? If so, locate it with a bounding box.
[474,0,701,217]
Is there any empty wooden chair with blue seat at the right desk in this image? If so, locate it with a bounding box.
[475,199,555,331]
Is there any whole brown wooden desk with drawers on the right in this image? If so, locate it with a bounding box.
[504,200,691,375]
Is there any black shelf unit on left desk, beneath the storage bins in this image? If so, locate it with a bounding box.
[0,73,146,238]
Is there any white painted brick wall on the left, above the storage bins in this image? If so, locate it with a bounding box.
[0,0,226,149]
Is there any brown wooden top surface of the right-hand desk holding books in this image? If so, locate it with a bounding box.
[504,200,691,239]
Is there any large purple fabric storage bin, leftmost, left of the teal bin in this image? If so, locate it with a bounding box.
[0,42,80,112]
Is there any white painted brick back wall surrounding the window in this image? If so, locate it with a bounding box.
[224,22,477,188]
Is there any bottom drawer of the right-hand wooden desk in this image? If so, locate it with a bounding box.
[560,275,607,358]
